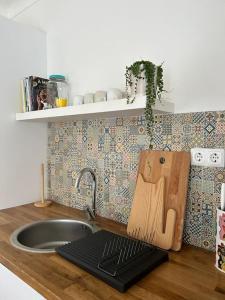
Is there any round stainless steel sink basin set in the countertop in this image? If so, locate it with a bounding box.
[10,219,95,253]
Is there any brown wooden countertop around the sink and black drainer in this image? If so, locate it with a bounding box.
[0,203,225,300]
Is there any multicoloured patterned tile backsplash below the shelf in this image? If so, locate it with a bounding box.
[48,112,225,250]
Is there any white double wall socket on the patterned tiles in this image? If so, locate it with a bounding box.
[191,148,225,168]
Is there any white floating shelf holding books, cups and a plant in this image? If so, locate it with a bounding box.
[16,97,174,122]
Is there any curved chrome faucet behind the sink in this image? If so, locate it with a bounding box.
[75,168,96,220]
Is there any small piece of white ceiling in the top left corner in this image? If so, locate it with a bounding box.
[0,0,39,18]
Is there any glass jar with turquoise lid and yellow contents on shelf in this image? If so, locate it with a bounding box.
[47,75,69,107]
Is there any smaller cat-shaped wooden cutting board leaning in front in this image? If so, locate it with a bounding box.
[127,174,176,250]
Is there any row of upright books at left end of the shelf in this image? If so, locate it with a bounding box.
[21,76,48,112]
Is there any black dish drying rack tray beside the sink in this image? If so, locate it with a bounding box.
[56,230,168,292]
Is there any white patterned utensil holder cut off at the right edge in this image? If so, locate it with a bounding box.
[215,208,225,273]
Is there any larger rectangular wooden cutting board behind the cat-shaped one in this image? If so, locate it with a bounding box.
[128,150,190,251]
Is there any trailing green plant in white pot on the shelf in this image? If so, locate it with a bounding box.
[125,60,164,149]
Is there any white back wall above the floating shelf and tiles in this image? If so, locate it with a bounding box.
[13,0,225,112]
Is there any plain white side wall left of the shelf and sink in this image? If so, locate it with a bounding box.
[0,17,47,209]
